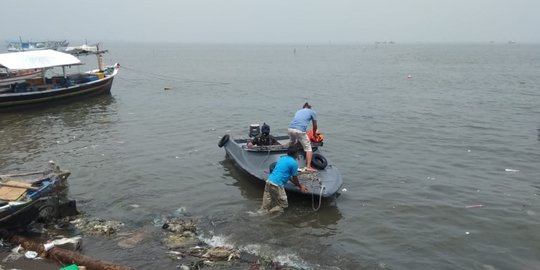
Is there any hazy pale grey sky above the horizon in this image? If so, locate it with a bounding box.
[0,0,540,44]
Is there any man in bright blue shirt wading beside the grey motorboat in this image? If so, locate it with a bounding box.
[261,145,307,214]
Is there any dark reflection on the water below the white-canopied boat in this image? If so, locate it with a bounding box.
[0,95,114,167]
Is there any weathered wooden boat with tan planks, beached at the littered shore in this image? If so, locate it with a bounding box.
[0,162,70,228]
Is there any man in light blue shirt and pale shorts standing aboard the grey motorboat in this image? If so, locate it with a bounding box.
[288,102,317,171]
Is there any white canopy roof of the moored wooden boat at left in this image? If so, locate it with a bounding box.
[0,50,82,70]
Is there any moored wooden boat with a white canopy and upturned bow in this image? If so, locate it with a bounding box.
[0,46,120,108]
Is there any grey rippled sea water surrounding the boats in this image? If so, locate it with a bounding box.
[0,44,540,269]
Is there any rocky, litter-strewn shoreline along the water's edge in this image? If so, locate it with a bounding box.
[0,214,295,270]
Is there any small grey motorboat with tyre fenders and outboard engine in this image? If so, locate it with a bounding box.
[218,124,343,198]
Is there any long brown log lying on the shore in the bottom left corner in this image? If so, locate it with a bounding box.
[0,231,135,270]
